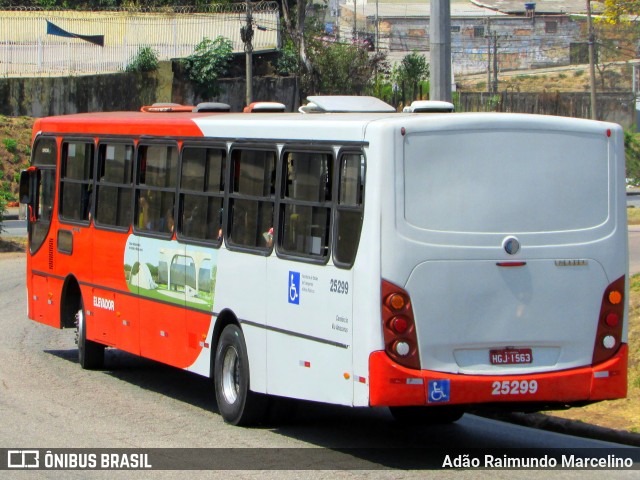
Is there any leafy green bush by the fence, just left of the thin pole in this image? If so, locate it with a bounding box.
[182,36,233,96]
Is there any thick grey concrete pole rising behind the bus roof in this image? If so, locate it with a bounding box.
[429,0,451,102]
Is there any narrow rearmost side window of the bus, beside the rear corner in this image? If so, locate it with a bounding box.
[333,153,365,268]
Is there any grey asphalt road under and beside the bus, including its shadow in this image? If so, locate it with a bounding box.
[0,254,637,479]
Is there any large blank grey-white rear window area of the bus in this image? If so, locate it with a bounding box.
[404,131,609,233]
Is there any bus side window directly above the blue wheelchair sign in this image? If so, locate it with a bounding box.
[278,152,333,259]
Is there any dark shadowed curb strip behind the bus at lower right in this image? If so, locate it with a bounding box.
[476,410,640,447]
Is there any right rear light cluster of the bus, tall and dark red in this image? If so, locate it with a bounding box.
[591,276,625,365]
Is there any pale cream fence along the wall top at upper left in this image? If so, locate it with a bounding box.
[0,1,279,77]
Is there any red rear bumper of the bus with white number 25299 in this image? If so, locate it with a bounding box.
[369,344,628,406]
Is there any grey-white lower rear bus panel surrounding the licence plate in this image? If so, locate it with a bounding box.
[406,259,609,375]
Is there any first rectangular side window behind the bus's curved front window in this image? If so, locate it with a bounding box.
[60,141,93,222]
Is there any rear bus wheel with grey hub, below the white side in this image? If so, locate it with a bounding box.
[213,324,268,426]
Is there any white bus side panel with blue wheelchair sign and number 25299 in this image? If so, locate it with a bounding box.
[266,257,353,405]
